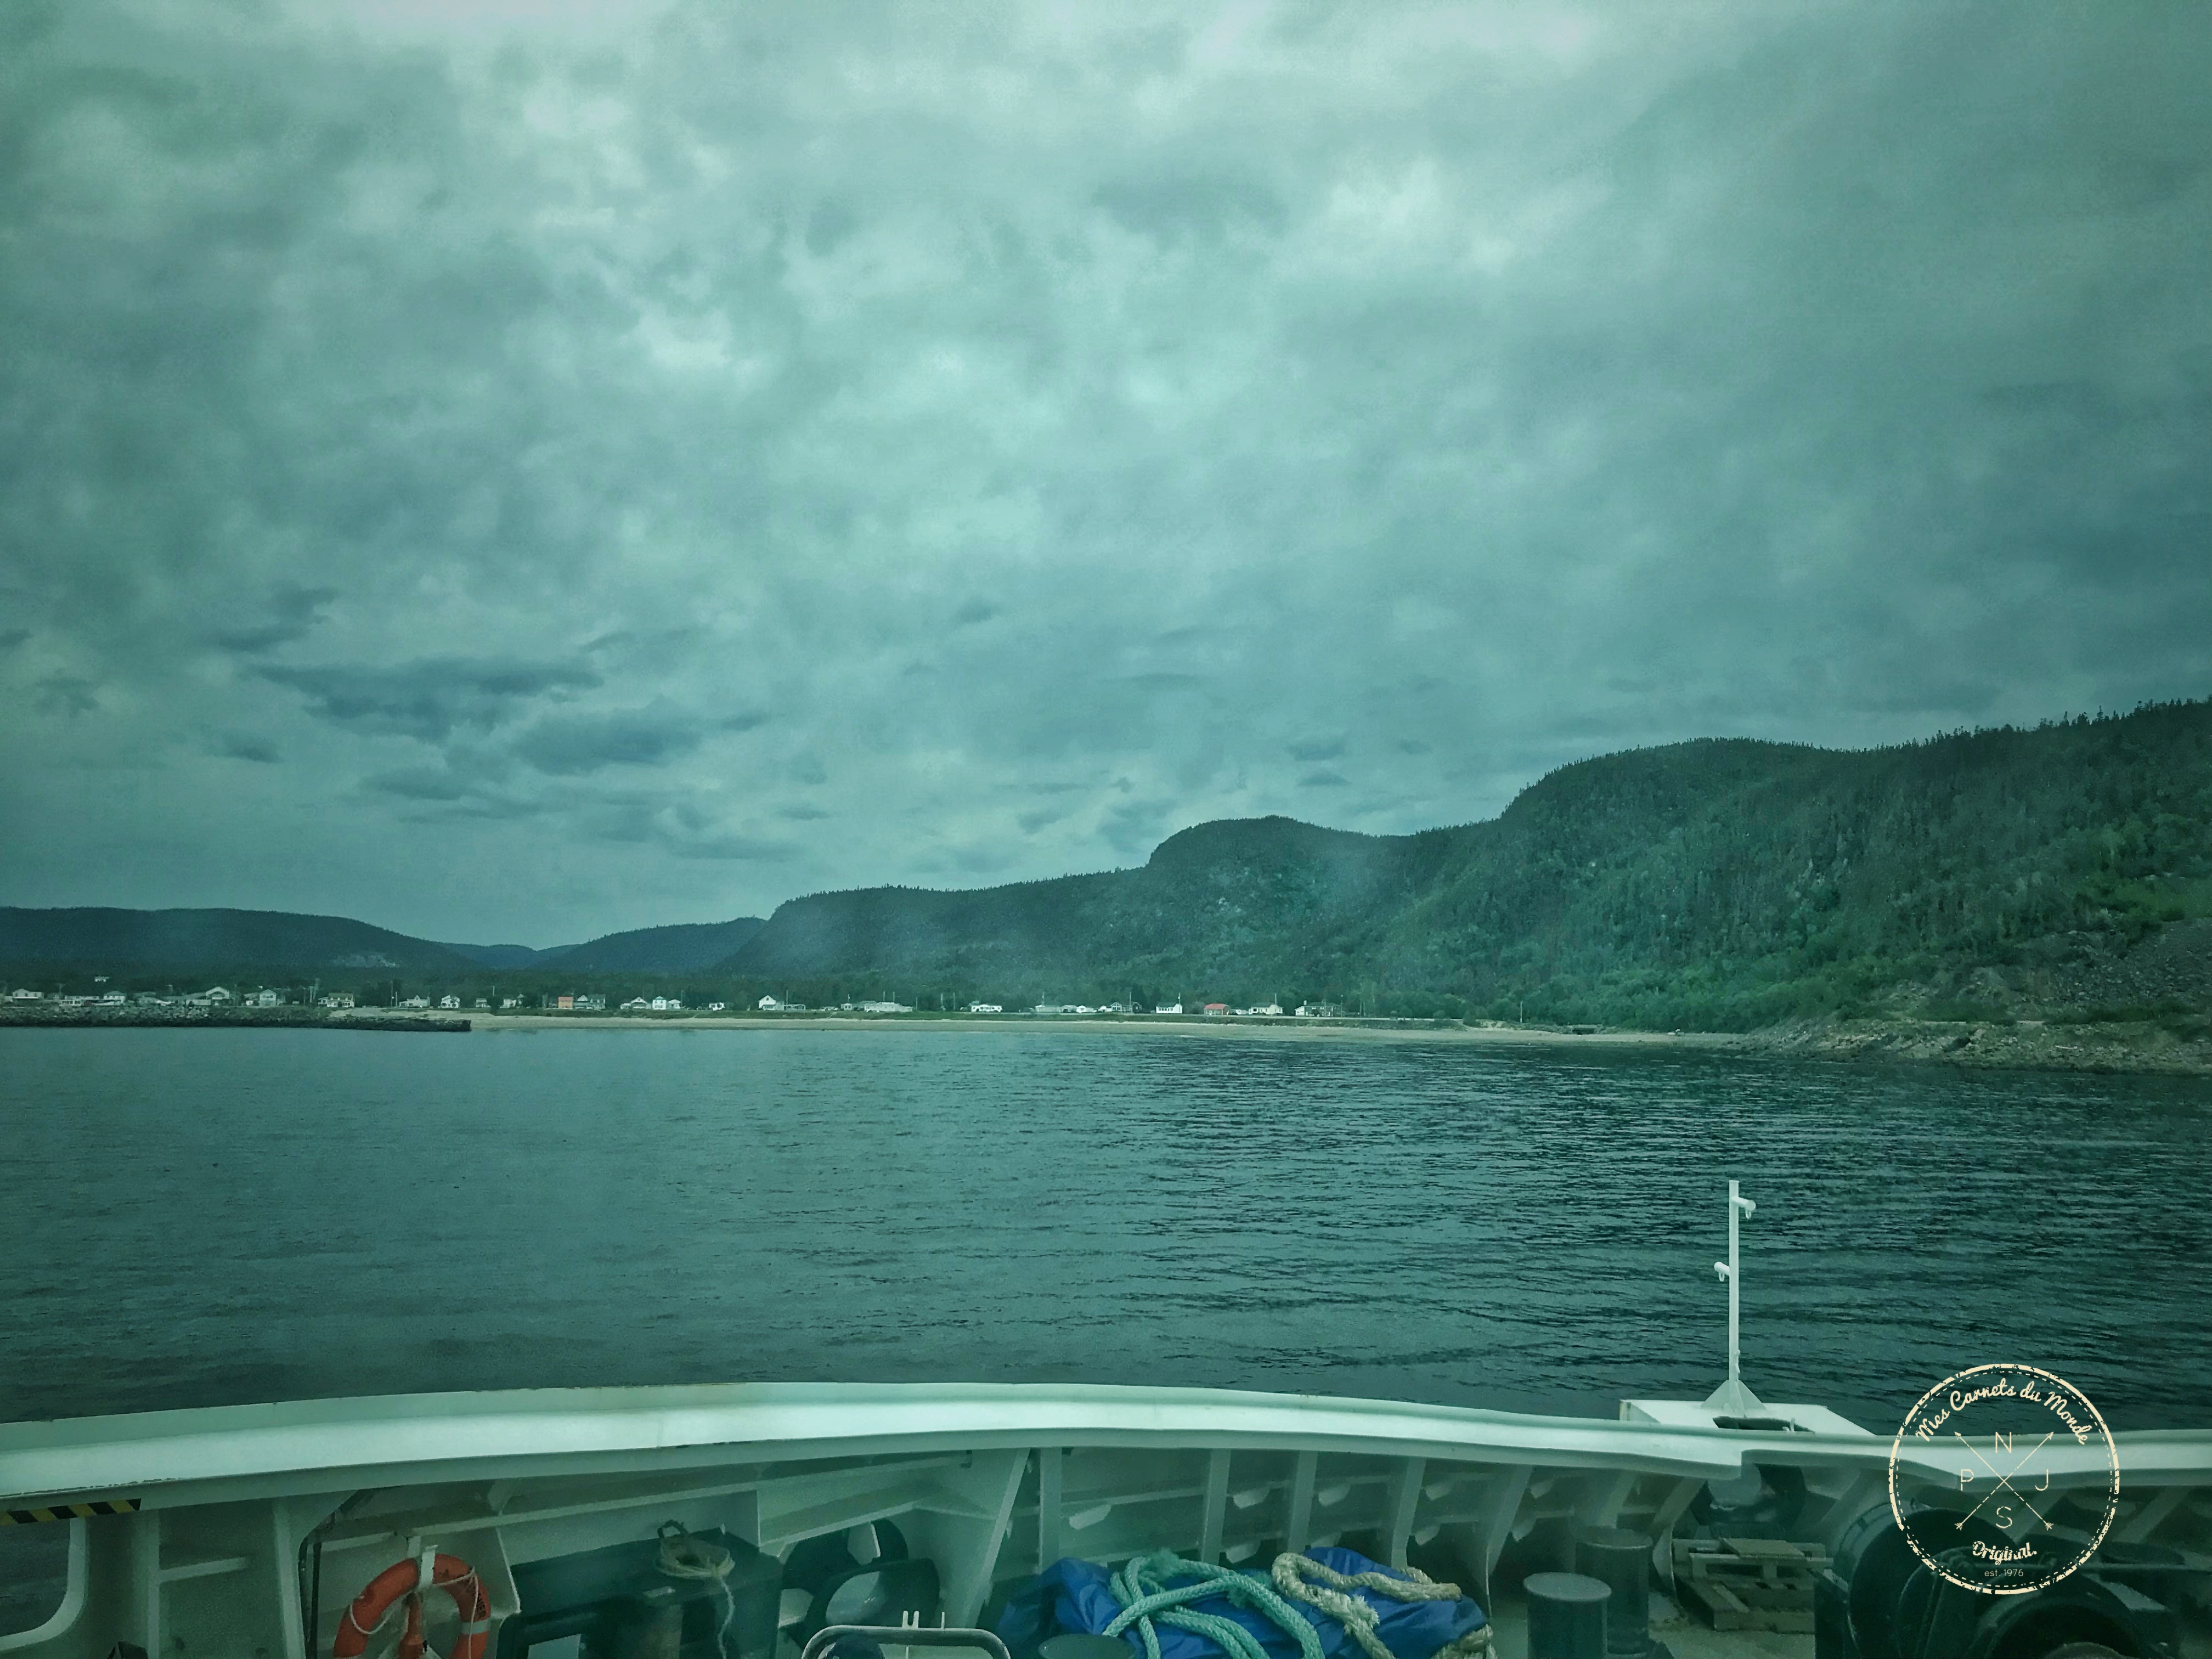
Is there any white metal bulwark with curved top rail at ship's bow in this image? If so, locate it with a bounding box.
[0,1385,2212,1659]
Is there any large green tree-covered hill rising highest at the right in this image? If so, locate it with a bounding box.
[723,701,2212,1029]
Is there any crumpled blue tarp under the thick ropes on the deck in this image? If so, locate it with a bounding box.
[1000,1548,1482,1659]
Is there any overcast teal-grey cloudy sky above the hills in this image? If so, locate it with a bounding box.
[0,0,2212,945]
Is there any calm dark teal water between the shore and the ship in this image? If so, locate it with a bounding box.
[0,1031,2212,1429]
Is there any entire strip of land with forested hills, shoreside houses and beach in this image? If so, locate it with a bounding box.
[0,701,2212,1068]
